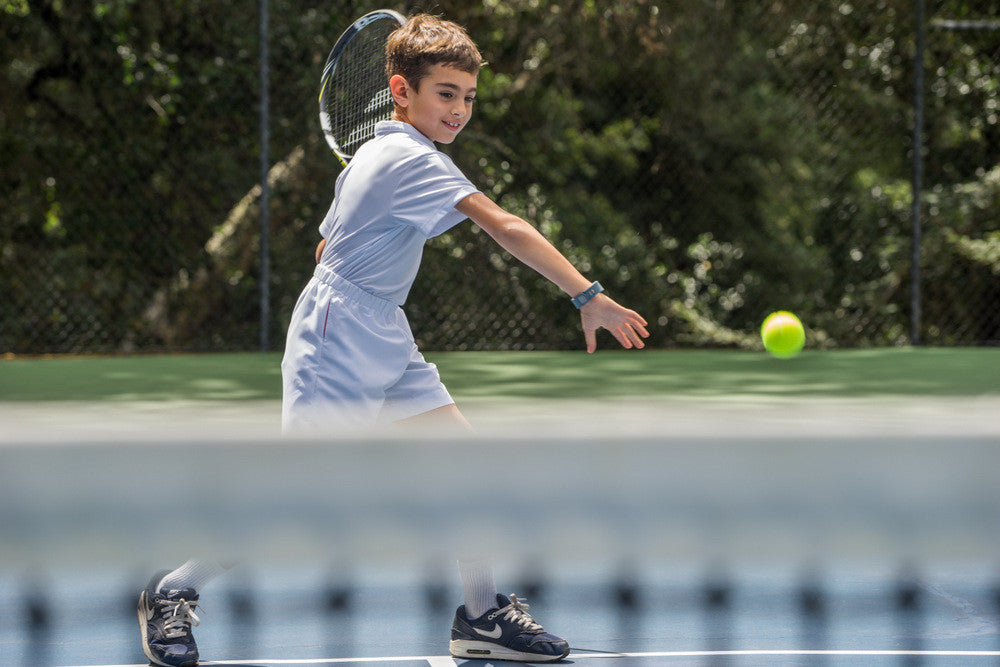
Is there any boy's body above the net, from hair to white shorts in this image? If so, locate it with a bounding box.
[282,15,648,431]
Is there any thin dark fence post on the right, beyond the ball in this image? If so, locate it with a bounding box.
[910,0,924,345]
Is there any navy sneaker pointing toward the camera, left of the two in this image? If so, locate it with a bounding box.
[139,570,199,667]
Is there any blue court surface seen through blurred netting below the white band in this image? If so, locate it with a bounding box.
[0,563,1000,667]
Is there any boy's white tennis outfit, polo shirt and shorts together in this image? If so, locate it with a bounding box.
[281,121,477,433]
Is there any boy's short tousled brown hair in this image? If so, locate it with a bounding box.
[385,14,484,90]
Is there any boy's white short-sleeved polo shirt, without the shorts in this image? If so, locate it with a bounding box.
[319,121,478,305]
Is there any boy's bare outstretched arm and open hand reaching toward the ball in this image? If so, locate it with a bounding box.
[455,192,649,352]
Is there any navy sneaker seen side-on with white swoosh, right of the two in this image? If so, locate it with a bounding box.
[448,595,569,662]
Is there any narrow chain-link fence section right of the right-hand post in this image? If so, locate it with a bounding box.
[920,13,1000,344]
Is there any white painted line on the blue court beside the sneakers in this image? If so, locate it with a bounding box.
[67,649,1000,667]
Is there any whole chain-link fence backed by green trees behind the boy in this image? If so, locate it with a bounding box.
[0,0,1000,353]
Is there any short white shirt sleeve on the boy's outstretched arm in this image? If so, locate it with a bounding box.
[392,153,478,238]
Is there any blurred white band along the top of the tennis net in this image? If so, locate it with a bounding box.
[0,402,1000,566]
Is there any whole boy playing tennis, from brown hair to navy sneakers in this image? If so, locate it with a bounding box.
[139,15,649,666]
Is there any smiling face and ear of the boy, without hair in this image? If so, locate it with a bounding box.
[389,64,478,144]
